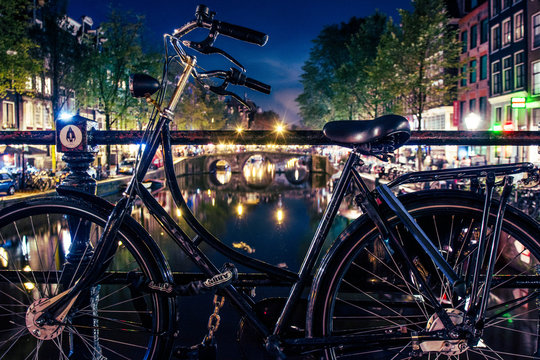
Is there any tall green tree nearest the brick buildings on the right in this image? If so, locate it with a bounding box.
[380,0,461,130]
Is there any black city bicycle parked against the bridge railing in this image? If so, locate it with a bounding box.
[0,5,540,359]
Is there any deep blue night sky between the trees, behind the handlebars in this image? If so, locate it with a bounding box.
[68,0,411,123]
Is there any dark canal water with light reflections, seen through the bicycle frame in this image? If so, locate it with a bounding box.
[116,160,349,359]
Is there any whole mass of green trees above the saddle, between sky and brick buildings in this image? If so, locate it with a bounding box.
[296,0,460,127]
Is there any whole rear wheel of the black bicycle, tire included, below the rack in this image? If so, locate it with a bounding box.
[306,190,540,360]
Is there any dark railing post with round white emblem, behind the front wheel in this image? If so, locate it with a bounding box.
[56,115,102,359]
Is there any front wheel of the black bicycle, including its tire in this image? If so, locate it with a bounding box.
[0,198,174,360]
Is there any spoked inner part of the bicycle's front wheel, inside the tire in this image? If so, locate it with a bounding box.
[0,207,167,359]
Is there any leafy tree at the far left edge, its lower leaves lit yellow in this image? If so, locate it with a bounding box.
[0,0,42,97]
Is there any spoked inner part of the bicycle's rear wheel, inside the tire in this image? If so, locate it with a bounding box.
[322,202,539,359]
